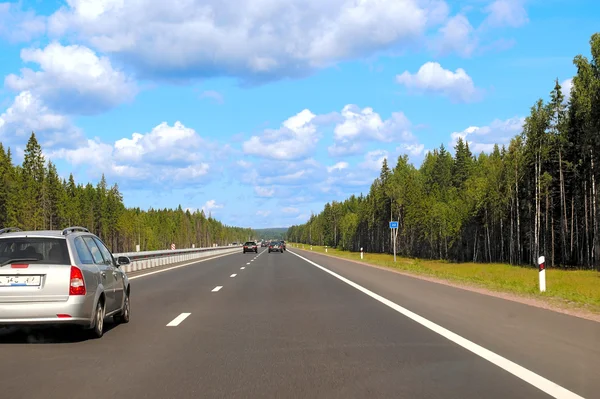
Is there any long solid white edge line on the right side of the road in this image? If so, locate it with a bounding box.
[289,251,583,399]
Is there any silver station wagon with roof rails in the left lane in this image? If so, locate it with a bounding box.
[0,227,131,338]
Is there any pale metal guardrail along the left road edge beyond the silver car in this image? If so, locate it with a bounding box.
[113,245,242,273]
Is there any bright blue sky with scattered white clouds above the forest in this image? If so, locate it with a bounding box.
[0,0,600,228]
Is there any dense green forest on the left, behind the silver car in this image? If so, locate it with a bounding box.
[0,133,253,252]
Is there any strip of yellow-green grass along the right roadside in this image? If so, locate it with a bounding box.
[293,244,600,313]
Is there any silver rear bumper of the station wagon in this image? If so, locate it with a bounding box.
[0,296,92,326]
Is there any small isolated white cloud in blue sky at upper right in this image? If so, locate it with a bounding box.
[396,62,481,103]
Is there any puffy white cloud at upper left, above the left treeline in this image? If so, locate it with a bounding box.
[4,42,137,114]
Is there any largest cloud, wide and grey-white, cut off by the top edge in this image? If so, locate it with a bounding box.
[49,0,448,81]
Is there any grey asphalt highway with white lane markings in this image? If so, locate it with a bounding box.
[0,248,600,399]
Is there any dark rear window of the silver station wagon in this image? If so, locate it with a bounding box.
[0,237,71,265]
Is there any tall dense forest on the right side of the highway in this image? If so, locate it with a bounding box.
[287,33,600,269]
